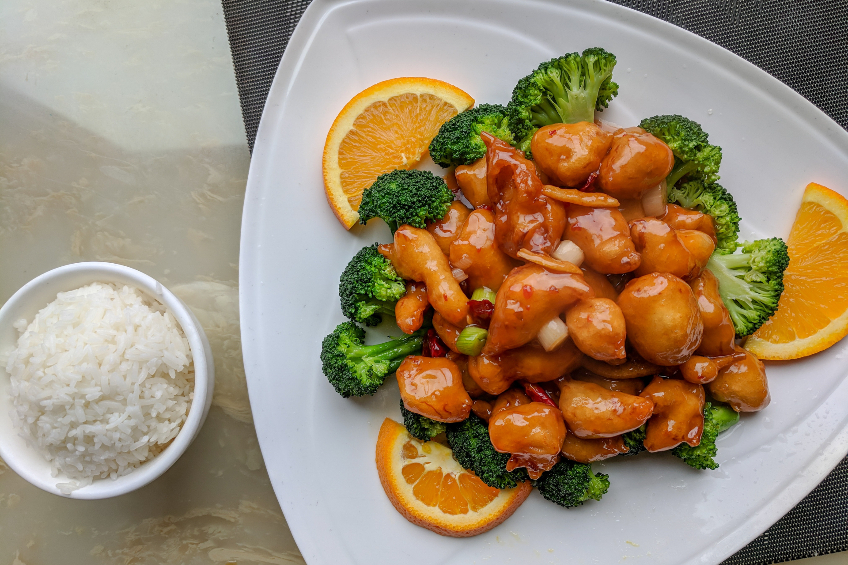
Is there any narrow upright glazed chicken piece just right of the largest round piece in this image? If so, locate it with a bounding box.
[689,269,736,357]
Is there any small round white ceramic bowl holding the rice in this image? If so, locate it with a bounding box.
[0,263,215,499]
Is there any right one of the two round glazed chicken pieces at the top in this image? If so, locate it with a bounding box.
[598,128,674,198]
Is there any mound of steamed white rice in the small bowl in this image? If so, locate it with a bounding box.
[6,283,194,492]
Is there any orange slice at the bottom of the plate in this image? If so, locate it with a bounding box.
[377,418,532,537]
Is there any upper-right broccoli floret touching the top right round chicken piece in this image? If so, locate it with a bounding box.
[639,115,721,189]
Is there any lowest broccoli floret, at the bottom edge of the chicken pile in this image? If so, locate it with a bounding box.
[536,459,609,508]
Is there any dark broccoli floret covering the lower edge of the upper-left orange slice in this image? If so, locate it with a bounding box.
[359,169,454,233]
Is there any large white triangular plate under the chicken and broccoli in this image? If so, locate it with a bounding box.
[240,0,848,565]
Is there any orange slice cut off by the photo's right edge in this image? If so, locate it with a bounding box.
[745,183,848,360]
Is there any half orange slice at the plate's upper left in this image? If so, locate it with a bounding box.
[323,77,474,229]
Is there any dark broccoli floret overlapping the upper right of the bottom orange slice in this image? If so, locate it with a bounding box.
[447,414,530,489]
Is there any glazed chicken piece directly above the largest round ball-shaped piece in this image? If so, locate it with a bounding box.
[630,218,715,280]
